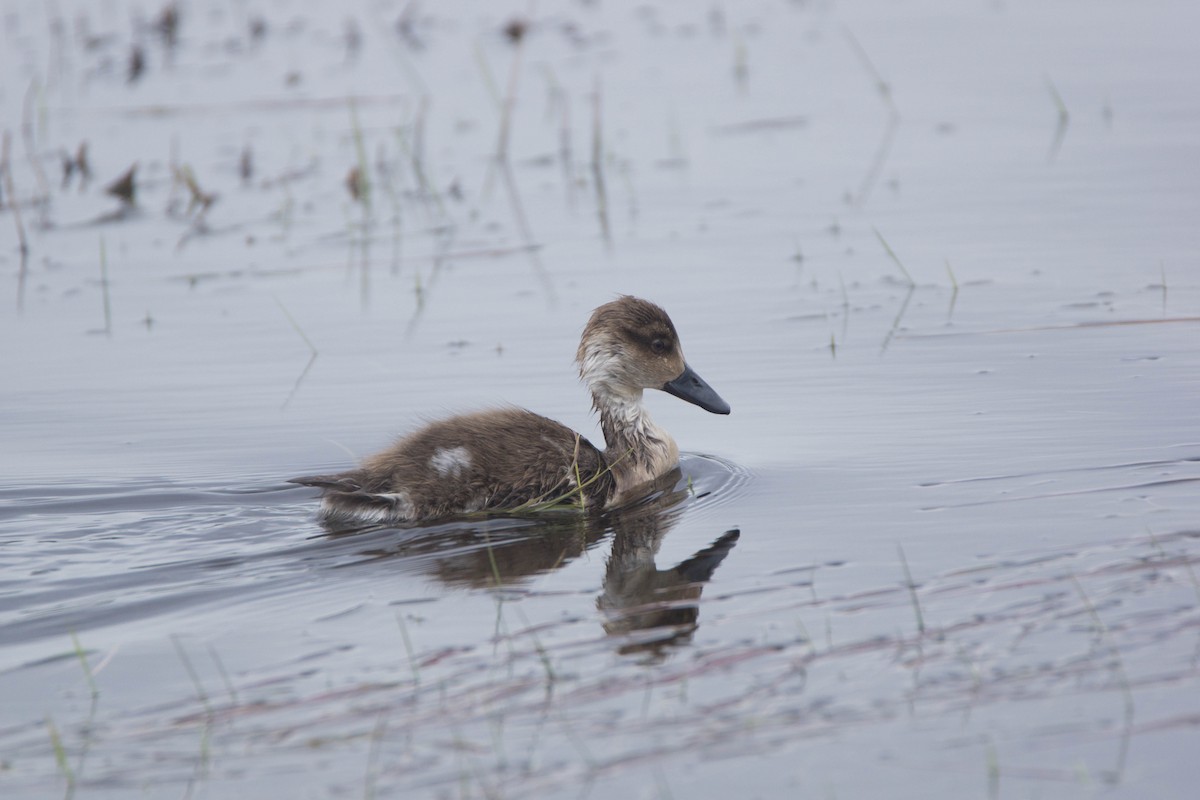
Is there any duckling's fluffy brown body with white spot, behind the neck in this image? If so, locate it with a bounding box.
[294,409,613,523]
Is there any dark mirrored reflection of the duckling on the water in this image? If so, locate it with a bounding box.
[314,469,739,661]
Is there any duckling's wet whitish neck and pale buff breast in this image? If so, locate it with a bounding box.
[592,389,679,503]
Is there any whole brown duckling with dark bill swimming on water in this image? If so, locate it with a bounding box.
[290,295,730,525]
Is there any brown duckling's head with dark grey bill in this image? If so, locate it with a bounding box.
[575,295,730,414]
